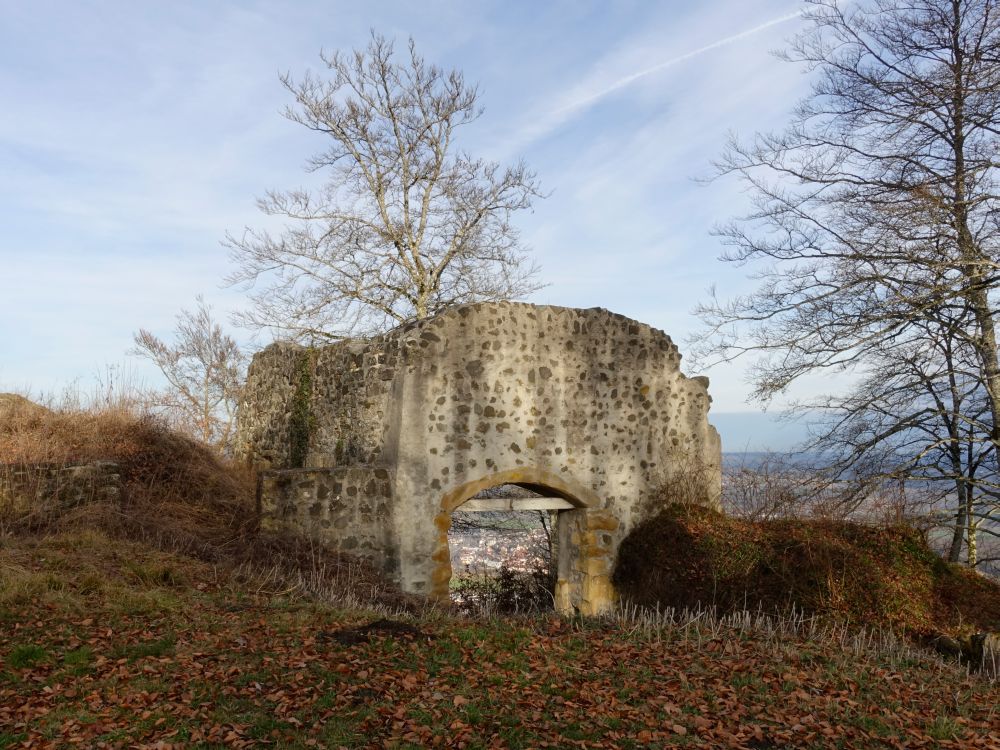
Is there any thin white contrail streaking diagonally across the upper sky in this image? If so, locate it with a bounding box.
[507,10,802,152]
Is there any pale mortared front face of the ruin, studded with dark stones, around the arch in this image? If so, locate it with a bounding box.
[385,304,718,590]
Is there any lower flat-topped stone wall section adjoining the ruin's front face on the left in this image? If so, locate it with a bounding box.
[258,466,399,573]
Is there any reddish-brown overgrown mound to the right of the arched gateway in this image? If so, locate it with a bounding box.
[615,504,1000,636]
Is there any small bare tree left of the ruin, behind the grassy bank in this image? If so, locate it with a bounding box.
[130,296,247,452]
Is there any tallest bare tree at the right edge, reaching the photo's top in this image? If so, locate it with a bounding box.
[698,0,1000,512]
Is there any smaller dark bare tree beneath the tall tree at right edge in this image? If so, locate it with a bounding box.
[804,302,1000,565]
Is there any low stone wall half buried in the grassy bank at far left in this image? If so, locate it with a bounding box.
[0,461,122,517]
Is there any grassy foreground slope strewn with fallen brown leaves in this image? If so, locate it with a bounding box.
[0,533,1000,748]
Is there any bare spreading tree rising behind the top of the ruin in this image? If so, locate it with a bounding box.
[225,33,539,339]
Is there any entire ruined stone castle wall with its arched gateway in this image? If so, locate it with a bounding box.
[238,303,720,614]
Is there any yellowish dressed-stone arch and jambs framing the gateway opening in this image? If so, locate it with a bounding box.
[429,467,619,615]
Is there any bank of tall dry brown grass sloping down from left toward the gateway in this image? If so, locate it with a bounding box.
[0,394,416,610]
